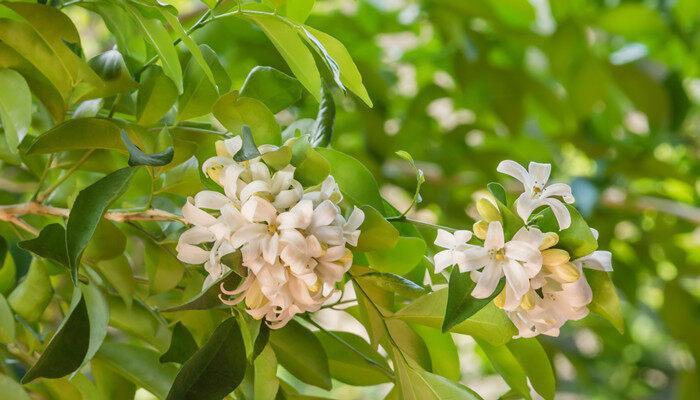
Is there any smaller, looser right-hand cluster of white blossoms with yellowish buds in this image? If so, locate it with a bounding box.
[435,161,612,337]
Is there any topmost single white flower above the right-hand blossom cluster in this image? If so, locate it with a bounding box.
[497,160,574,229]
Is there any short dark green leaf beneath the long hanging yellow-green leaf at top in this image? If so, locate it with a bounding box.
[241,66,302,114]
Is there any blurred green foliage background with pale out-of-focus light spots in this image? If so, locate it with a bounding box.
[66,0,700,399]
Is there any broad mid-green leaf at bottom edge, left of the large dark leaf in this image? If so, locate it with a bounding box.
[95,342,177,399]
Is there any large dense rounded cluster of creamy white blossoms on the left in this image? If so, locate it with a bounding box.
[177,136,364,328]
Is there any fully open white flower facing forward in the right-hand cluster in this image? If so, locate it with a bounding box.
[460,221,543,309]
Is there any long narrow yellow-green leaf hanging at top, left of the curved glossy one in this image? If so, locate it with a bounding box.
[246,14,321,102]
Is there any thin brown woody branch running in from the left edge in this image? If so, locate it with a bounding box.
[0,202,185,225]
